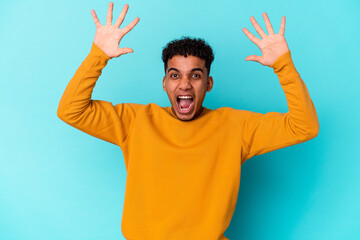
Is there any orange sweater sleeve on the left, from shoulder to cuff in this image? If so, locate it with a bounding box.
[57,43,135,147]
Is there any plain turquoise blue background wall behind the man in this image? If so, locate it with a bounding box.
[0,0,360,240]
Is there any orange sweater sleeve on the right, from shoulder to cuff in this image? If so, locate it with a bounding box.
[242,51,319,162]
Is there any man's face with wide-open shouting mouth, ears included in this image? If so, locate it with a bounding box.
[163,55,213,121]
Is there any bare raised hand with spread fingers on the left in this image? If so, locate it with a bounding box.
[91,2,140,58]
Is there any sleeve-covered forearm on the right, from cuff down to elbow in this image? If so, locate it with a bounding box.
[270,51,319,141]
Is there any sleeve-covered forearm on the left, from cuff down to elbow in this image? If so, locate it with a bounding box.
[57,43,110,122]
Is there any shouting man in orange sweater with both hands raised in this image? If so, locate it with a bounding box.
[58,3,319,240]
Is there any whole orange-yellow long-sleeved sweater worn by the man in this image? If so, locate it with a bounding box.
[57,43,319,240]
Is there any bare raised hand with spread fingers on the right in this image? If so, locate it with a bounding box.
[242,13,289,66]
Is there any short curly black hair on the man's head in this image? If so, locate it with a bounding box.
[162,37,214,76]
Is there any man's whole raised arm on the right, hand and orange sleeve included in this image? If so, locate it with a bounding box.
[241,14,319,161]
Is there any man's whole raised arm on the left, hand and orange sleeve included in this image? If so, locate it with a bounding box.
[57,3,139,146]
